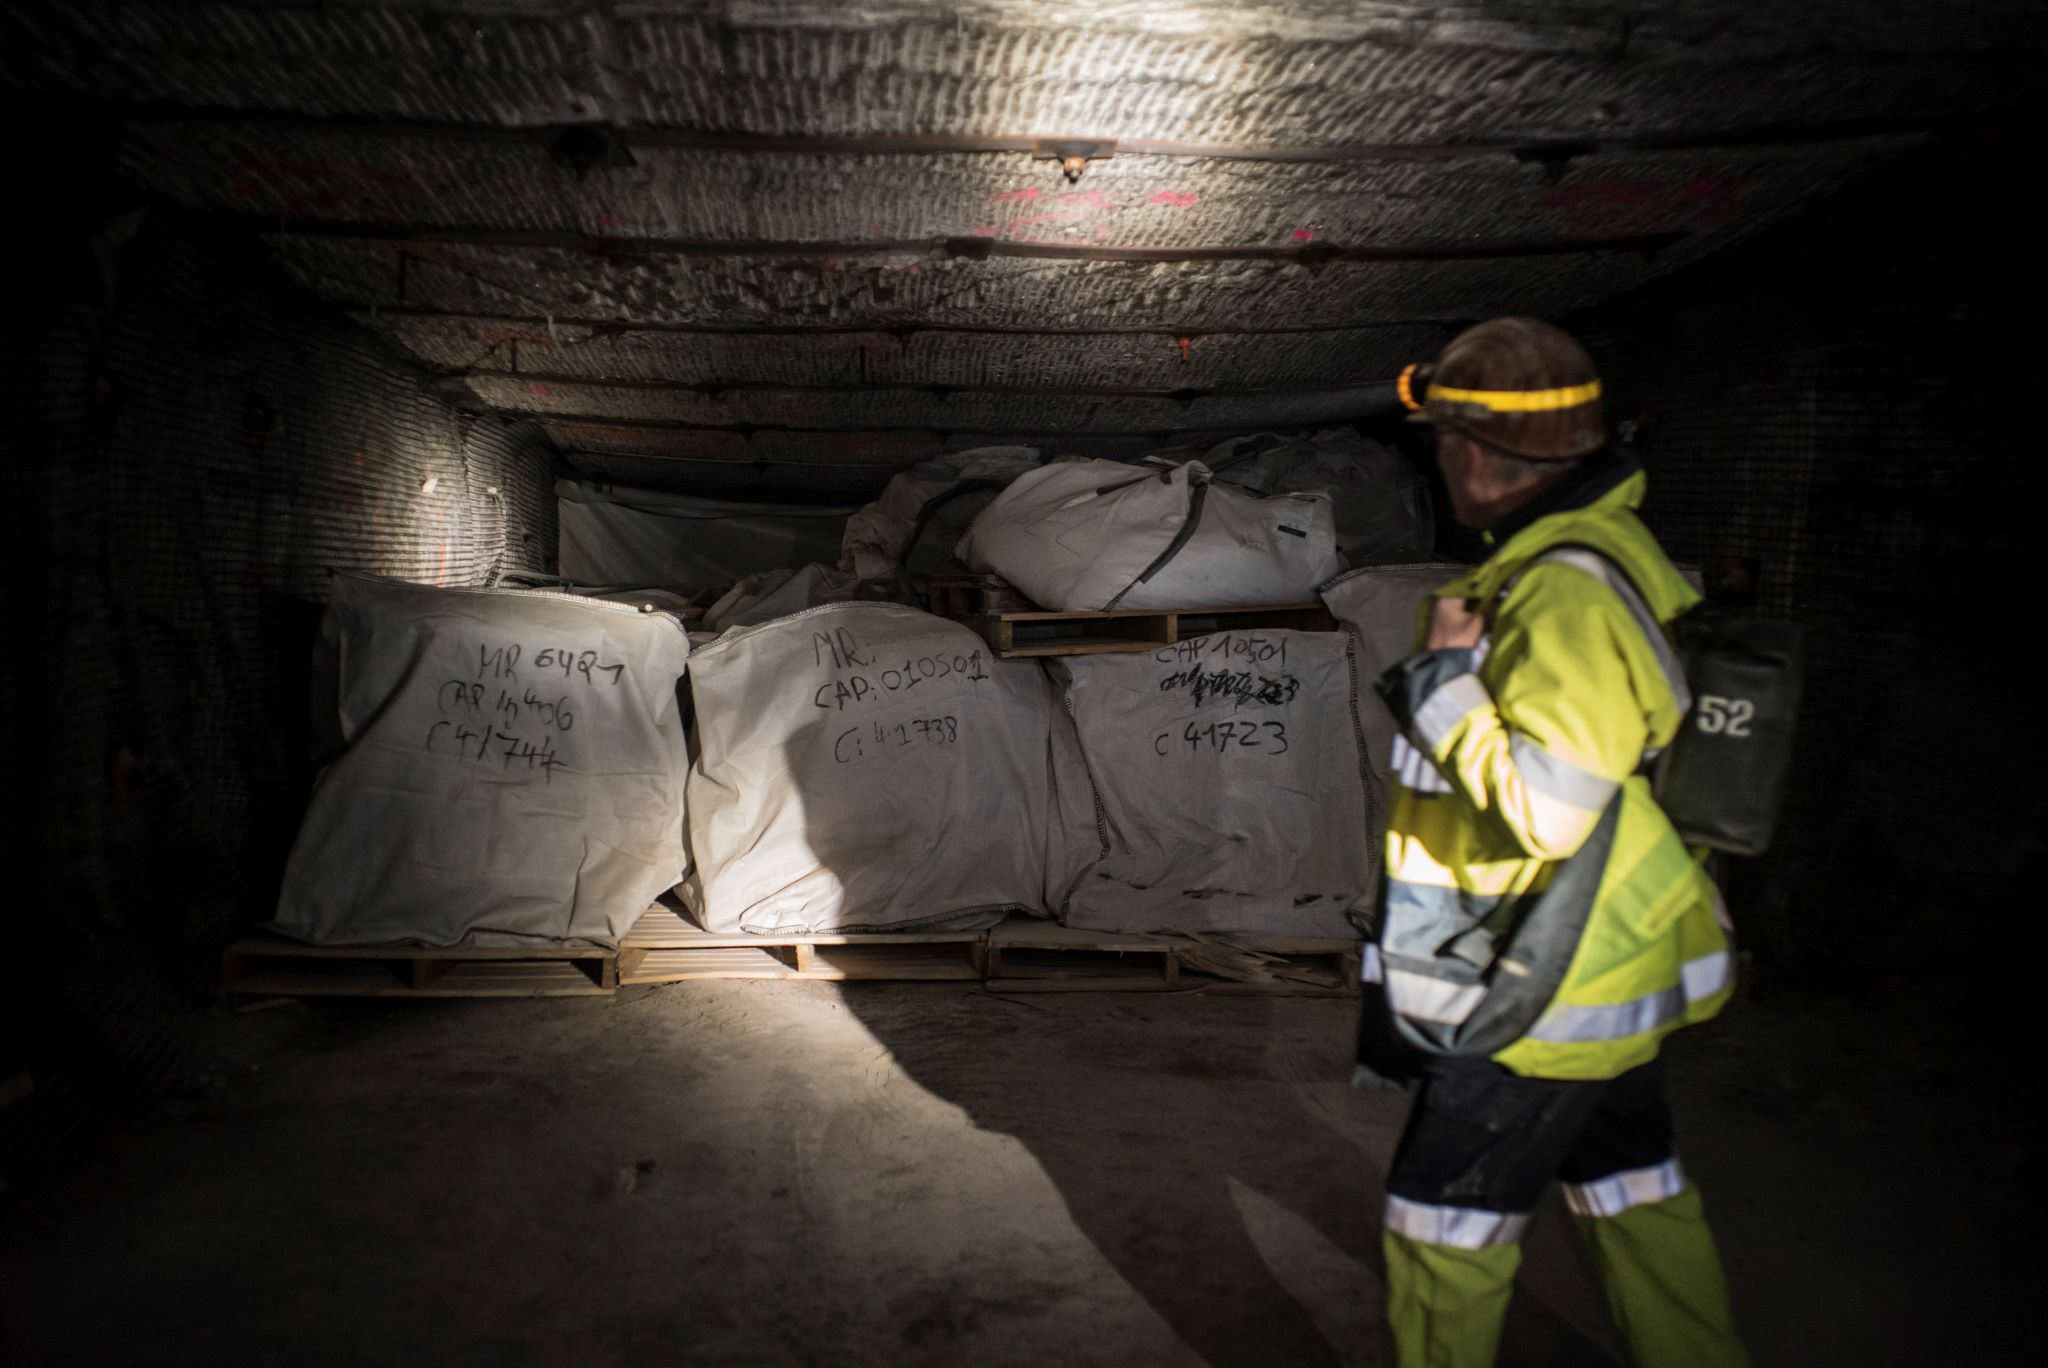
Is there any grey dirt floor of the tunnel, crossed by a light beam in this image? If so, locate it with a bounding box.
[0,983,2038,1368]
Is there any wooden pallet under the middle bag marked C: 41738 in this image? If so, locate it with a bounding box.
[618,907,987,985]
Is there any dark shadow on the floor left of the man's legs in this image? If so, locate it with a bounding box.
[844,985,1376,1368]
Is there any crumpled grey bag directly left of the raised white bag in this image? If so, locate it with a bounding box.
[840,446,1038,575]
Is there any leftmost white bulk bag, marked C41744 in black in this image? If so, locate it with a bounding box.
[272,575,690,946]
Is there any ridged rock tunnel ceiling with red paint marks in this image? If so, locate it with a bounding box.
[0,0,2044,494]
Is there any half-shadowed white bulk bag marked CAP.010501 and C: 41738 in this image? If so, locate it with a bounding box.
[686,602,1057,934]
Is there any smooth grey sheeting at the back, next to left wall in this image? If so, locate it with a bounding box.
[555,479,854,594]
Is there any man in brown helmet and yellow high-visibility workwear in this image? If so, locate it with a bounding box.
[1360,319,1747,1368]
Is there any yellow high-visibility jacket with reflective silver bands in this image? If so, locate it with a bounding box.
[1368,461,1733,1079]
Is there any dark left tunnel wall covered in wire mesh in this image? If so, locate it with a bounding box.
[4,213,555,1163]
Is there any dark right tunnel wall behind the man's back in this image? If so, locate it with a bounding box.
[1583,147,2048,971]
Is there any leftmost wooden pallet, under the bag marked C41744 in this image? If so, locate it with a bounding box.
[221,934,618,997]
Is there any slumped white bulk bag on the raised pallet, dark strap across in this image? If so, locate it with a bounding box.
[961,461,1339,612]
